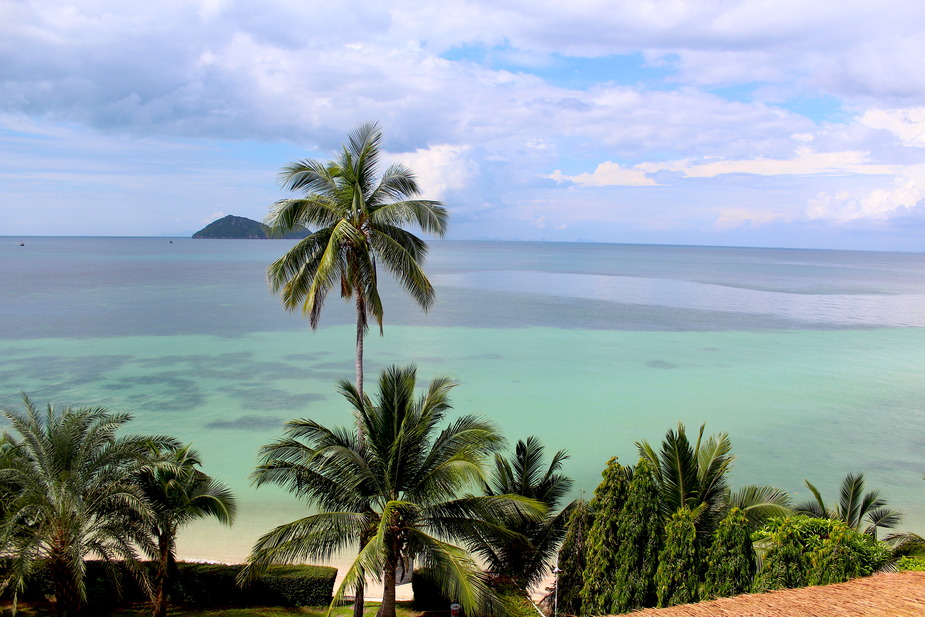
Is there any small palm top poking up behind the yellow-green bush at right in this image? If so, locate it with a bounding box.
[794,473,902,538]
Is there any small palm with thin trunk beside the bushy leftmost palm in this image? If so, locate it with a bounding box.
[137,446,236,617]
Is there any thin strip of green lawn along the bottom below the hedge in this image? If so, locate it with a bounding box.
[0,602,423,617]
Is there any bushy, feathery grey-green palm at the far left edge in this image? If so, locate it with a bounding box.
[0,397,178,615]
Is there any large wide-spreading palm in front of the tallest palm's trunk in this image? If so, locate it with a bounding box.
[241,366,542,617]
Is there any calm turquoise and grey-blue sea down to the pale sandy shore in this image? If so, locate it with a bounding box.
[0,238,925,560]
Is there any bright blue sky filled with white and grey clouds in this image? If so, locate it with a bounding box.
[0,0,925,251]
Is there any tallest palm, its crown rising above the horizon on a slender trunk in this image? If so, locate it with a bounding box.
[266,124,448,406]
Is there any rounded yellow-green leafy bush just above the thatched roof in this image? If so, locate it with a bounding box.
[752,516,890,591]
